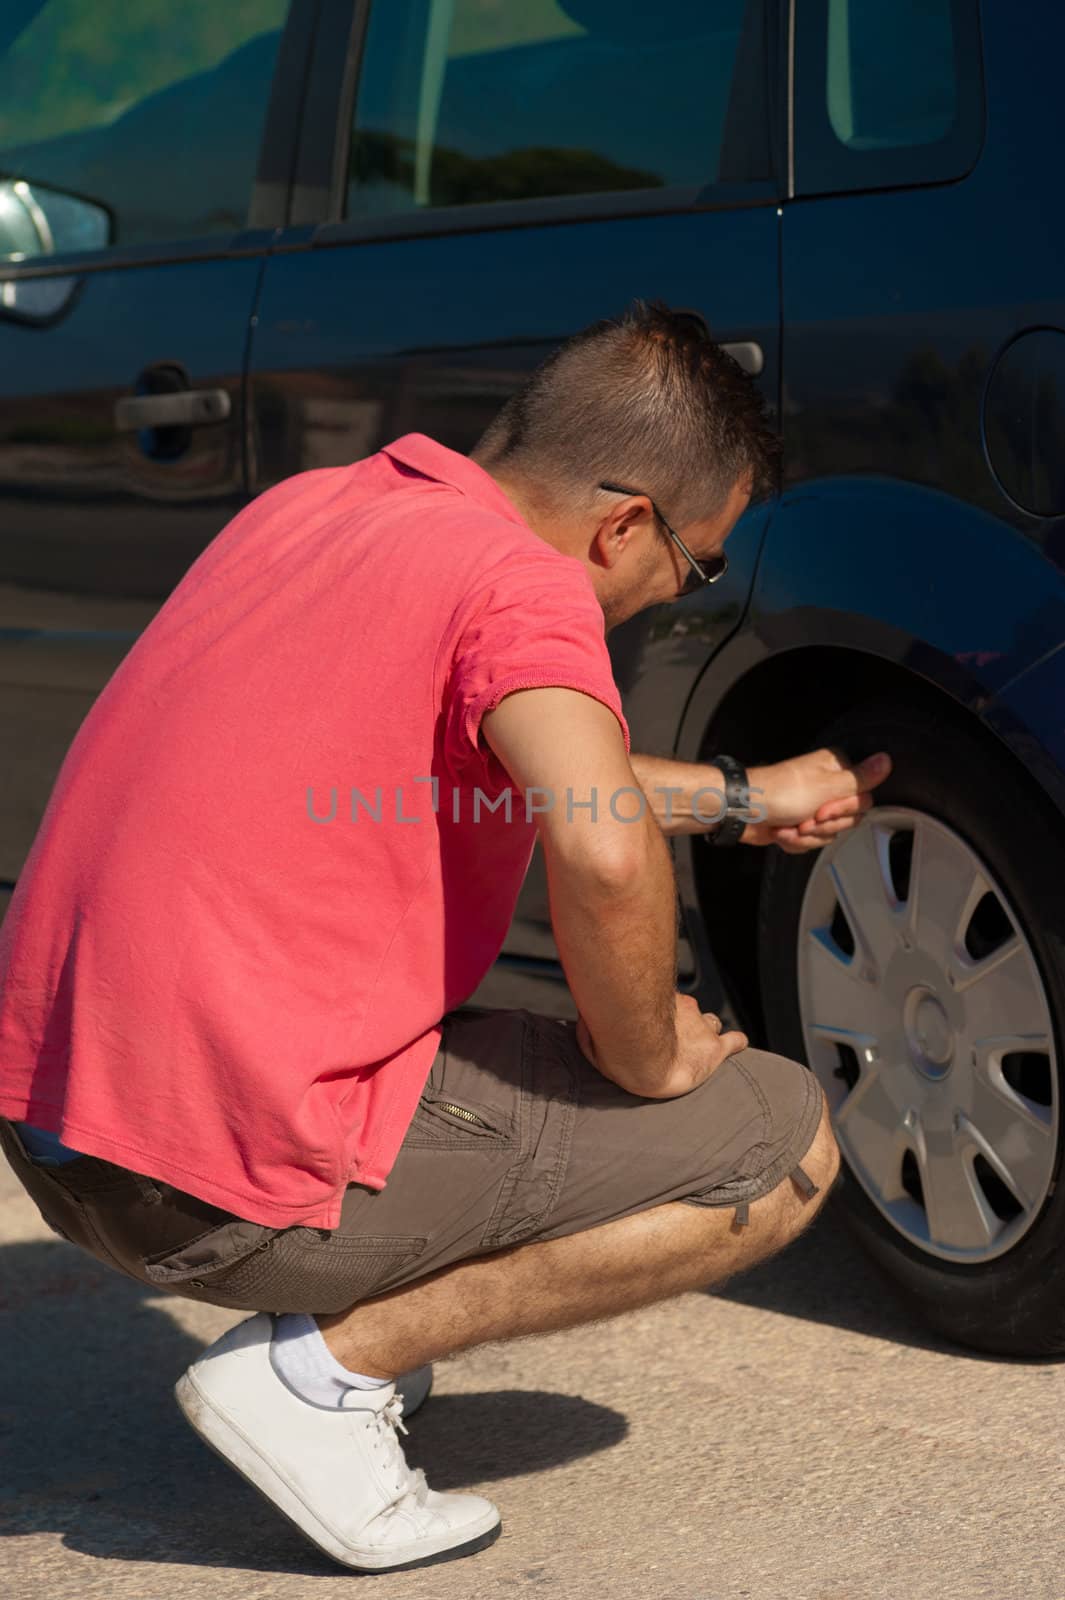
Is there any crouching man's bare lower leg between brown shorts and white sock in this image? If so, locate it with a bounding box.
[317,1109,840,1378]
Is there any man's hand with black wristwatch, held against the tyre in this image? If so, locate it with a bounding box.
[740,750,891,854]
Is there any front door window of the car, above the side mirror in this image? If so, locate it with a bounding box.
[0,0,288,261]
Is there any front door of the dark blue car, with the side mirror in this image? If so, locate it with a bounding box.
[0,0,309,914]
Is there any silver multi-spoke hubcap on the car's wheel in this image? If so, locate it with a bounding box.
[798,806,1059,1262]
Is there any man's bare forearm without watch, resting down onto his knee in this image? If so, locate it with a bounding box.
[544,818,676,1094]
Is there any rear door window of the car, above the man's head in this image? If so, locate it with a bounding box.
[347,0,769,216]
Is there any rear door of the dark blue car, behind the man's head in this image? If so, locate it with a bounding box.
[249,0,784,1004]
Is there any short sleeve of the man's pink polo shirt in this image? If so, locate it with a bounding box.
[443,558,630,790]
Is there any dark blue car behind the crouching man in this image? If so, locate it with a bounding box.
[0,0,1065,1354]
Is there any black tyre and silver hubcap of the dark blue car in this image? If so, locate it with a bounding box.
[758,704,1065,1355]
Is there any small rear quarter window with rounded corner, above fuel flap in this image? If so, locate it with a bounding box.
[796,0,983,194]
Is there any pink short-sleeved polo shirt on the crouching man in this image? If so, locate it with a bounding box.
[0,434,628,1227]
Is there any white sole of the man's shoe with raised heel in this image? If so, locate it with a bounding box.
[174,1373,502,1573]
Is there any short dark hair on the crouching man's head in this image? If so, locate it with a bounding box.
[472,301,780,525]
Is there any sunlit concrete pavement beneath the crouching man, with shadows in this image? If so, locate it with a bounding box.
[0,1166,1065,1600]
